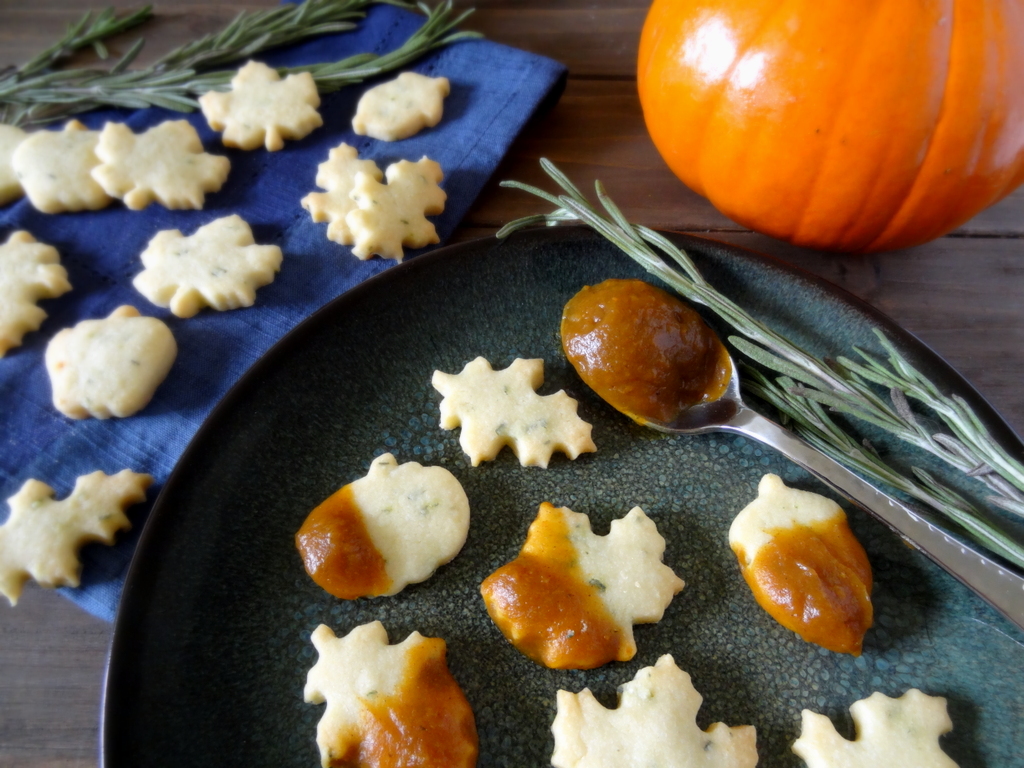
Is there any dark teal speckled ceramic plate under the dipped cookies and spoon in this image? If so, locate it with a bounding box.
[102,228,1024,768]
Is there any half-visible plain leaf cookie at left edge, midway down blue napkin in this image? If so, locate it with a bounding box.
[0,230,71,357]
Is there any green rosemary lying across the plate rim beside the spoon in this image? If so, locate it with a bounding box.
[497,160,1024,567]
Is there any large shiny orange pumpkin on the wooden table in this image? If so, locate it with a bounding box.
[637,0,1024,252]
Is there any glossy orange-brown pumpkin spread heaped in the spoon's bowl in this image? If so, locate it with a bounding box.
[561,280,732,424]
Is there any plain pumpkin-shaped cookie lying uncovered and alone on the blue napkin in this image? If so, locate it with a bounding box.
[46,305,178,419]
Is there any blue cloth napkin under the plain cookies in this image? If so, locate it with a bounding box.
[0,5,565,621]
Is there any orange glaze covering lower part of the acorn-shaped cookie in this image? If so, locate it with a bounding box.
[736,516,873,655]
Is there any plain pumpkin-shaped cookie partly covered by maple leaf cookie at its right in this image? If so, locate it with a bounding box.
[10,120,111,213]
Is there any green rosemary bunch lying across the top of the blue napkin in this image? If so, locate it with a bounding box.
[0,0,479,127]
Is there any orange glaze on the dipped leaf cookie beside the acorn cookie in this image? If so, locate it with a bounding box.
[480,502,622,670]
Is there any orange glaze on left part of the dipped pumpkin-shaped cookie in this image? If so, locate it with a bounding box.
[295,485,391,600]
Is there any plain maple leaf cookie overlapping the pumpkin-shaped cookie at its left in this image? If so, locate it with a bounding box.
[92,120,231,211]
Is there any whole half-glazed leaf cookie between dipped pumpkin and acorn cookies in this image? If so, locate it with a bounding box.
[480,502,684,670]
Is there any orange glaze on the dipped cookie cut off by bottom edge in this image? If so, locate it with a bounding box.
[331,637,479,768]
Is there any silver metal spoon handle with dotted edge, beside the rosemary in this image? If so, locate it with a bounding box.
[720,408,1024,629]
